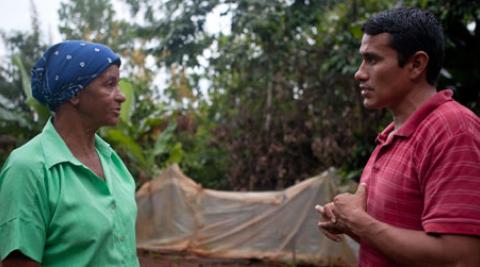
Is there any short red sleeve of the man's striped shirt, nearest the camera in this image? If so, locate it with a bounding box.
[420,132,480,236]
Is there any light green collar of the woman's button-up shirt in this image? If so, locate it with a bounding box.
[41,118,112,168]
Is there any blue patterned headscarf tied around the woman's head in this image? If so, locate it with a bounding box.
[32,40,121,111]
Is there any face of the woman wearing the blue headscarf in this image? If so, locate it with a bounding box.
[77,65,125,128]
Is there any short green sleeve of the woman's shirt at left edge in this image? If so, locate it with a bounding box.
[0,156,48,262]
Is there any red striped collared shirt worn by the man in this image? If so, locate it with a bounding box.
[359,90,480,267]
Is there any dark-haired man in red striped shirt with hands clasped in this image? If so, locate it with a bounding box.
[316,8,480,267]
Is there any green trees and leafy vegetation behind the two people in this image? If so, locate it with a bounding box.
[0,0,480,190]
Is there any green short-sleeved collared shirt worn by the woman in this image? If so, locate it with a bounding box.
[0,120,139,267]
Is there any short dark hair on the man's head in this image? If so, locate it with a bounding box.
[362,7,444,85]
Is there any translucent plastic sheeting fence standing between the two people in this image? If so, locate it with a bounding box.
[137,166,357,266]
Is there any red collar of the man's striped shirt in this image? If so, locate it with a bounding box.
[376,89,453,144]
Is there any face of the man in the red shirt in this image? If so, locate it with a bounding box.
[355,33,410,110]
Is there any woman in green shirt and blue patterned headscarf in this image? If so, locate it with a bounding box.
[0,41,138,267]
